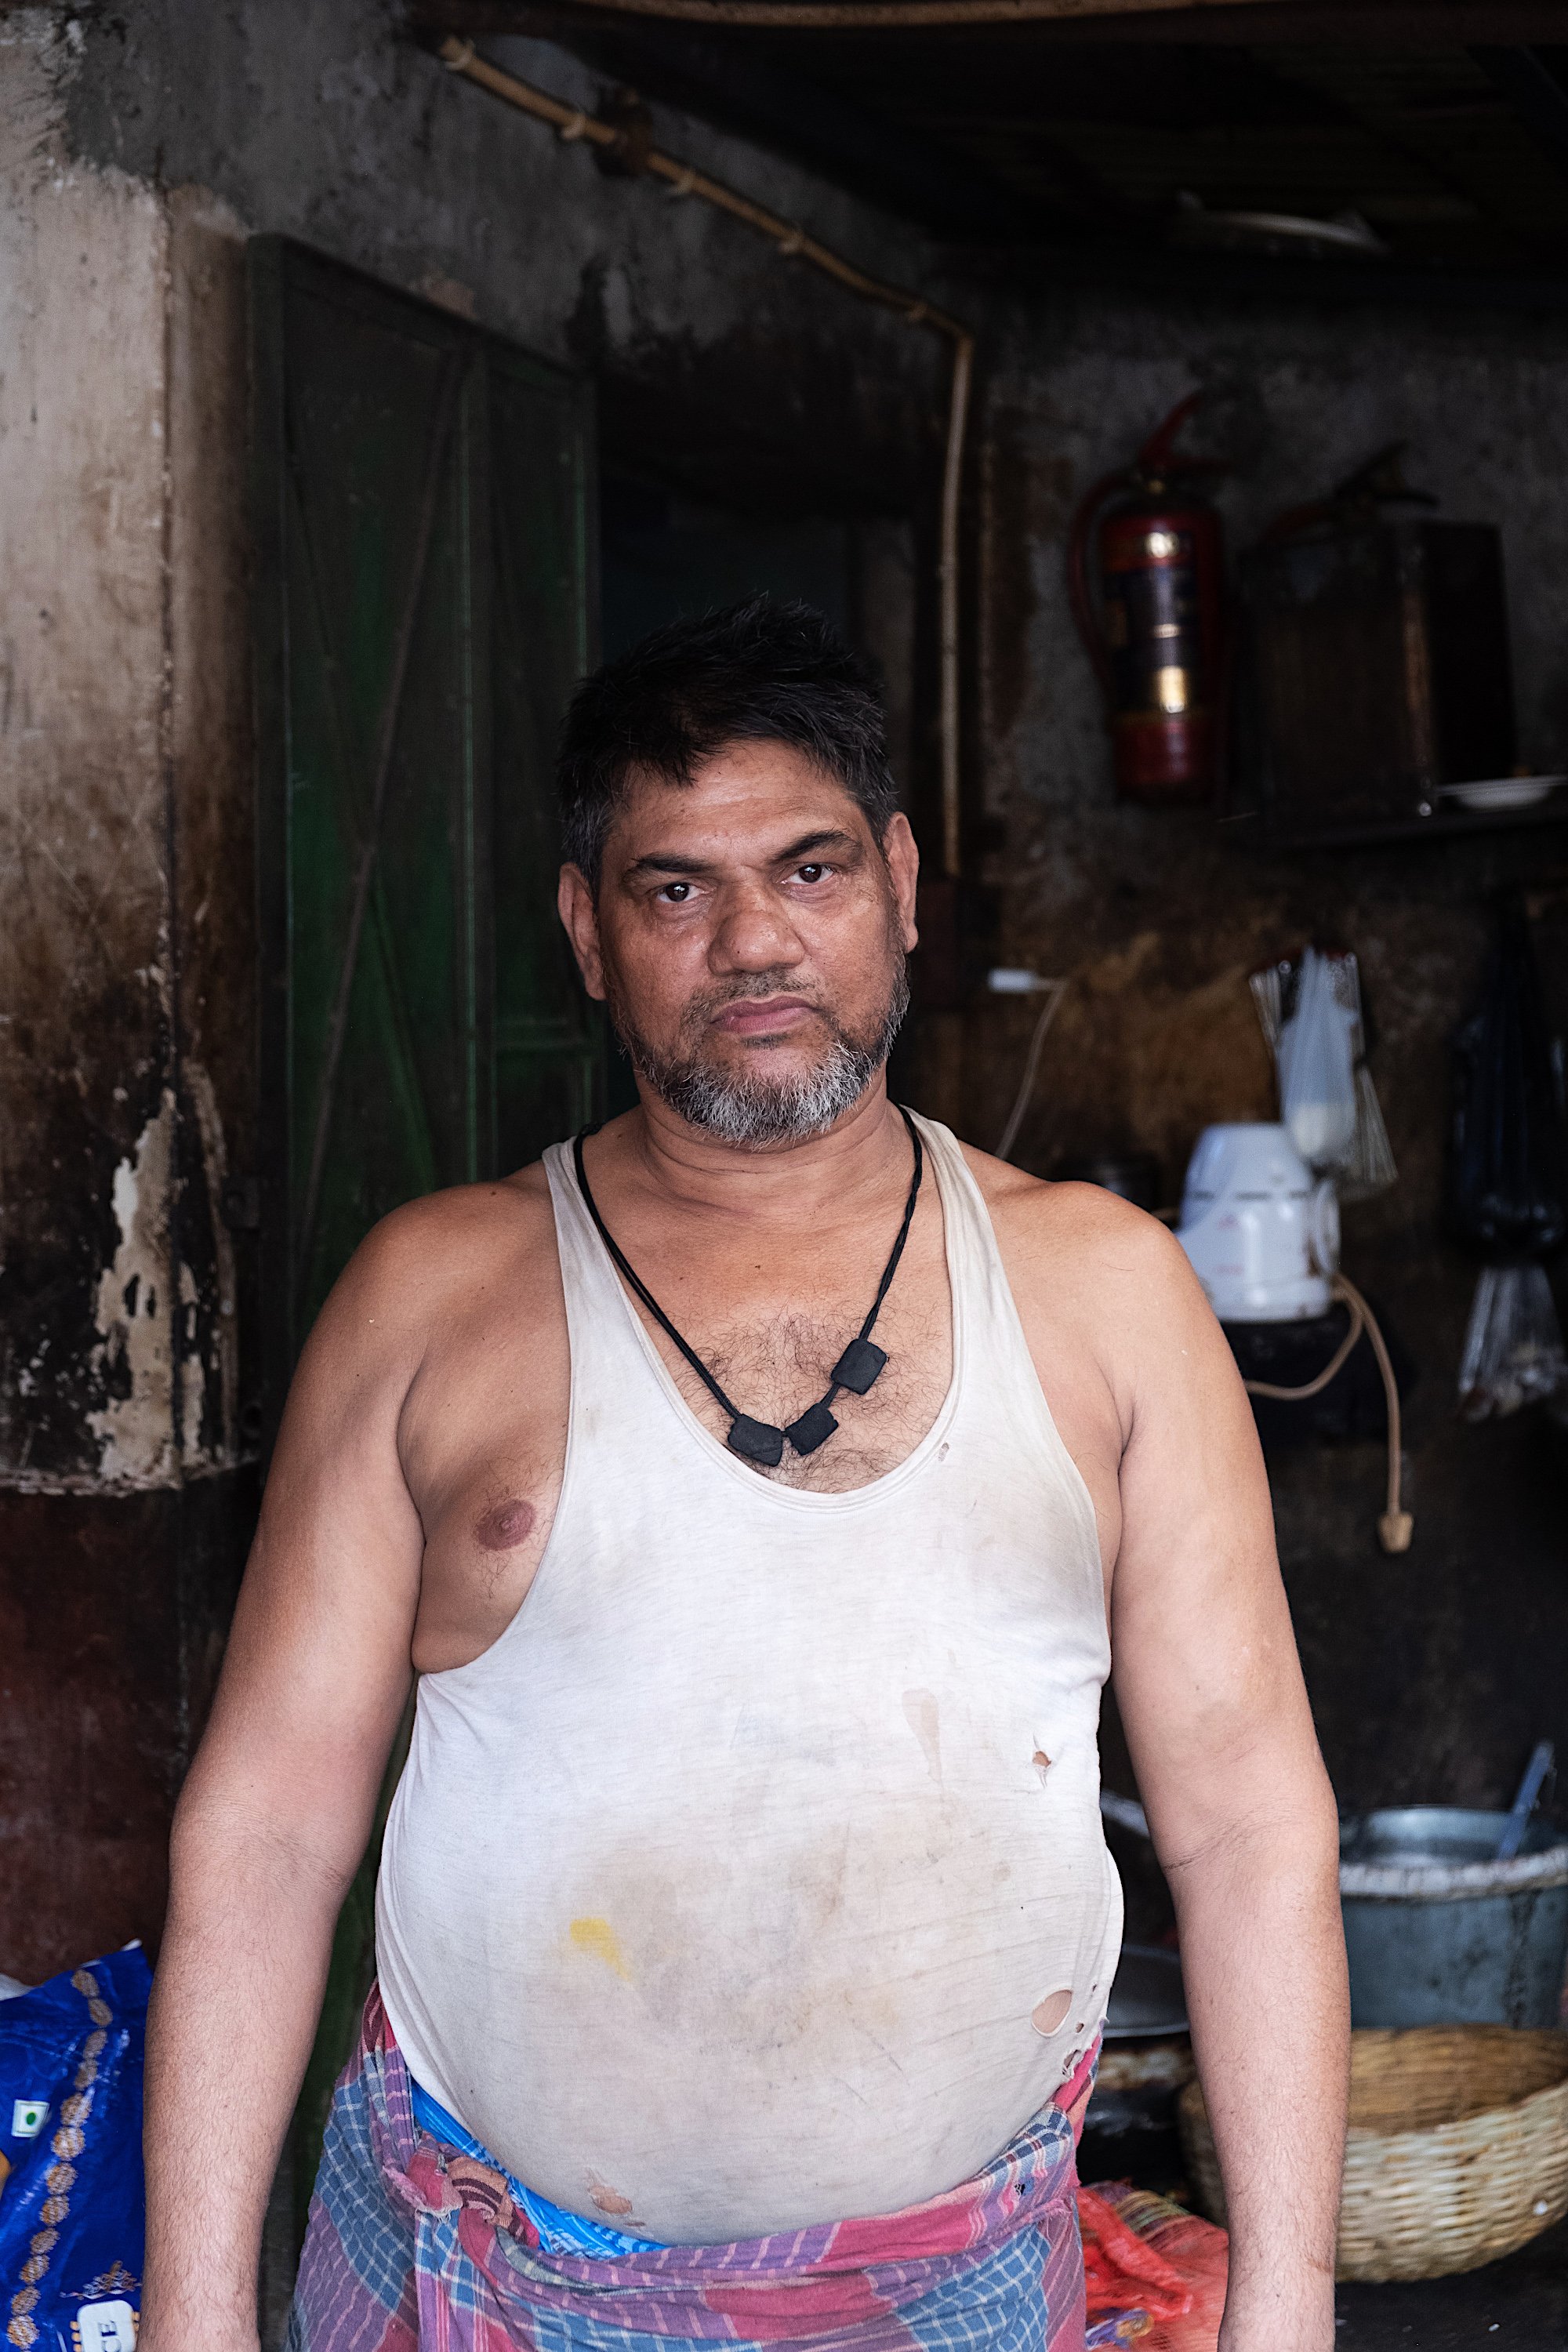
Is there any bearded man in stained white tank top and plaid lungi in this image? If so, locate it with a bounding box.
[143,602,1347,2352]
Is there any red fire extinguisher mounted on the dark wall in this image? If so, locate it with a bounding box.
[1067,393,1227,807]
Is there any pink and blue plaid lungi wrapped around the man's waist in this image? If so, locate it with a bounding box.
[287,1992,1098,2352]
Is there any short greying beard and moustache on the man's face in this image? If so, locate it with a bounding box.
[609,955,909,1152]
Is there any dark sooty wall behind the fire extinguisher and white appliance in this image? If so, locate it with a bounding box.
[966,285,1568,1882]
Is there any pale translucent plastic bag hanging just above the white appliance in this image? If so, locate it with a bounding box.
[1250,948,1399,1200]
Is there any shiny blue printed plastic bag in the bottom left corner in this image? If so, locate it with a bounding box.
[0,1943,153,2352]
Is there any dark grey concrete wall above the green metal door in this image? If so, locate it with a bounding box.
[71,0,959,524]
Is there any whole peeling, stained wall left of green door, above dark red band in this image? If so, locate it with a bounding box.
[0,24,252,1494]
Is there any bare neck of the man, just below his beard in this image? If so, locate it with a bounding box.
[628,1070,909,1225]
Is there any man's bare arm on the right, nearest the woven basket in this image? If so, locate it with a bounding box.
[1112,1218,1349,2352]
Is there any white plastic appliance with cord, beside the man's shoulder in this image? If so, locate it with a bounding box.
[1175,1122,1340,1322]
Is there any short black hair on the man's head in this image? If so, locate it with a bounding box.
[555,595,898,891]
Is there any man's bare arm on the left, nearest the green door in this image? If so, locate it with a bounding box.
[141,1207,433,2352]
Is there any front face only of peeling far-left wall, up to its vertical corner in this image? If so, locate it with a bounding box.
[0,18,174,1484]
